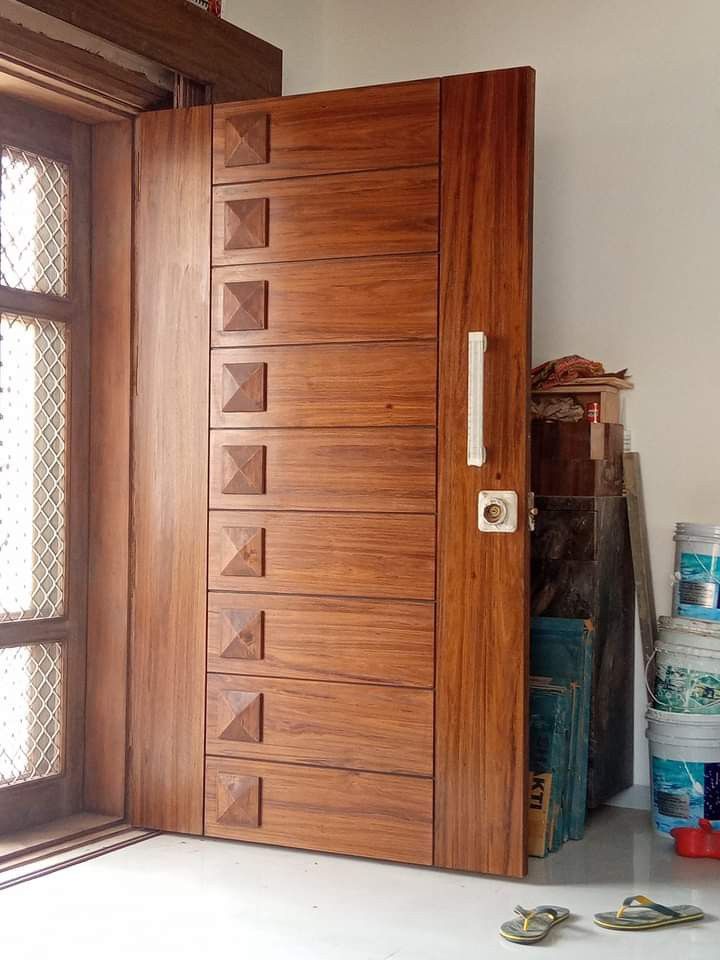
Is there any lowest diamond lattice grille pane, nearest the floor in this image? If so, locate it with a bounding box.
[0,643,63,788]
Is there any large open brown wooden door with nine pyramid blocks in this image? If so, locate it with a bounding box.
[130,68,533,875]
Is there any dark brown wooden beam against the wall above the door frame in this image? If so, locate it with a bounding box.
[16,0,282,103]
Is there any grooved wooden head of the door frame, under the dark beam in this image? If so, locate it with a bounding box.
[0,18,172,121]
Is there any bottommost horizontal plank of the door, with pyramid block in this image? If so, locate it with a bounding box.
[205,758,433,864]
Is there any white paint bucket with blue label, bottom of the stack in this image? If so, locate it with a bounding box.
[646,709,720,835]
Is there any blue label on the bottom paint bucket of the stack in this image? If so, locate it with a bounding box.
[652,757,720,833]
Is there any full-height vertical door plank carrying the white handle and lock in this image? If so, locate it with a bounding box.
[434,68,533,876]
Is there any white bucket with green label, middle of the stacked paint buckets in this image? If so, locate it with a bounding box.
[655,617,720,717]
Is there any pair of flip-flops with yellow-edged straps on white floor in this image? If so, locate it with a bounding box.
[500,896,704,943]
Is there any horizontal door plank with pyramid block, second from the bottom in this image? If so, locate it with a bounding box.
[206,673,433,776]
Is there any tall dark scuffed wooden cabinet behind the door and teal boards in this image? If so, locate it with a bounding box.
[531,498,635,808]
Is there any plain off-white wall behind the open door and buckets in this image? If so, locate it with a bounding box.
[228,0,720,782]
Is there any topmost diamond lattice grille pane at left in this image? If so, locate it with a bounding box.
[0,147,70,297]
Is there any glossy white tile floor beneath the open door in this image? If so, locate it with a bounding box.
[0,808,720,960]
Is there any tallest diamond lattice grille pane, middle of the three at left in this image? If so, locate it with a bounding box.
[0,313,67,621]
